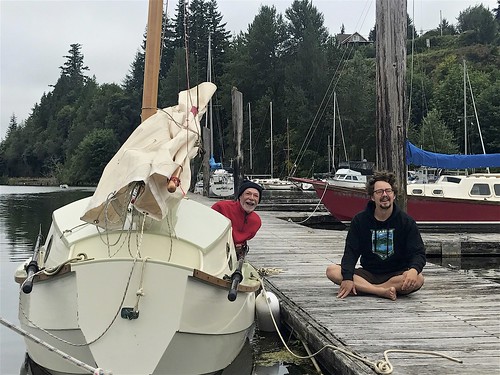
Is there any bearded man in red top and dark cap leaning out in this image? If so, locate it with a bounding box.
[212,180,262,260]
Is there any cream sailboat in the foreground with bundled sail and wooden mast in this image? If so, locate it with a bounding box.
[15,0,261,375]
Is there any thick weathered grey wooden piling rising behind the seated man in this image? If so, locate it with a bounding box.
[375,0,408,211]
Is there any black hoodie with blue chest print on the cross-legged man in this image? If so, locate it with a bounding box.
[341,201,426,280]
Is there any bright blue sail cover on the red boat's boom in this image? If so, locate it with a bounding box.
[406,141,500,169]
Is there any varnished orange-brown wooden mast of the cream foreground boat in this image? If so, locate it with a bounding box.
[141,0,163,122]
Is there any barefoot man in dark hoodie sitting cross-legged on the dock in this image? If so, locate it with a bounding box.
[326,171,426,301]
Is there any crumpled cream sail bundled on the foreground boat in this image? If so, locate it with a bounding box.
[81,82,216,229]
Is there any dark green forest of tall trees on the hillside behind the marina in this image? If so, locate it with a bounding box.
[0,0,500,185]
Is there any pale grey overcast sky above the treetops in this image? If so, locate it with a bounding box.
[0,0,497,139]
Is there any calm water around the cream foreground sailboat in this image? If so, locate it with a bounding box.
[0,186,316,375]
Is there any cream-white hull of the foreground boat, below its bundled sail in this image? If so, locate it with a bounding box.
[16,201,259,375]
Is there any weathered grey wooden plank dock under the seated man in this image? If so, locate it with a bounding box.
[188,197,500,375]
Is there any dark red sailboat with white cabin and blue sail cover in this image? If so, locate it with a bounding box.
[294,11,500,231]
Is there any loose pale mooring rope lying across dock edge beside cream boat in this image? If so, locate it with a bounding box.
[259,280,463,375]
